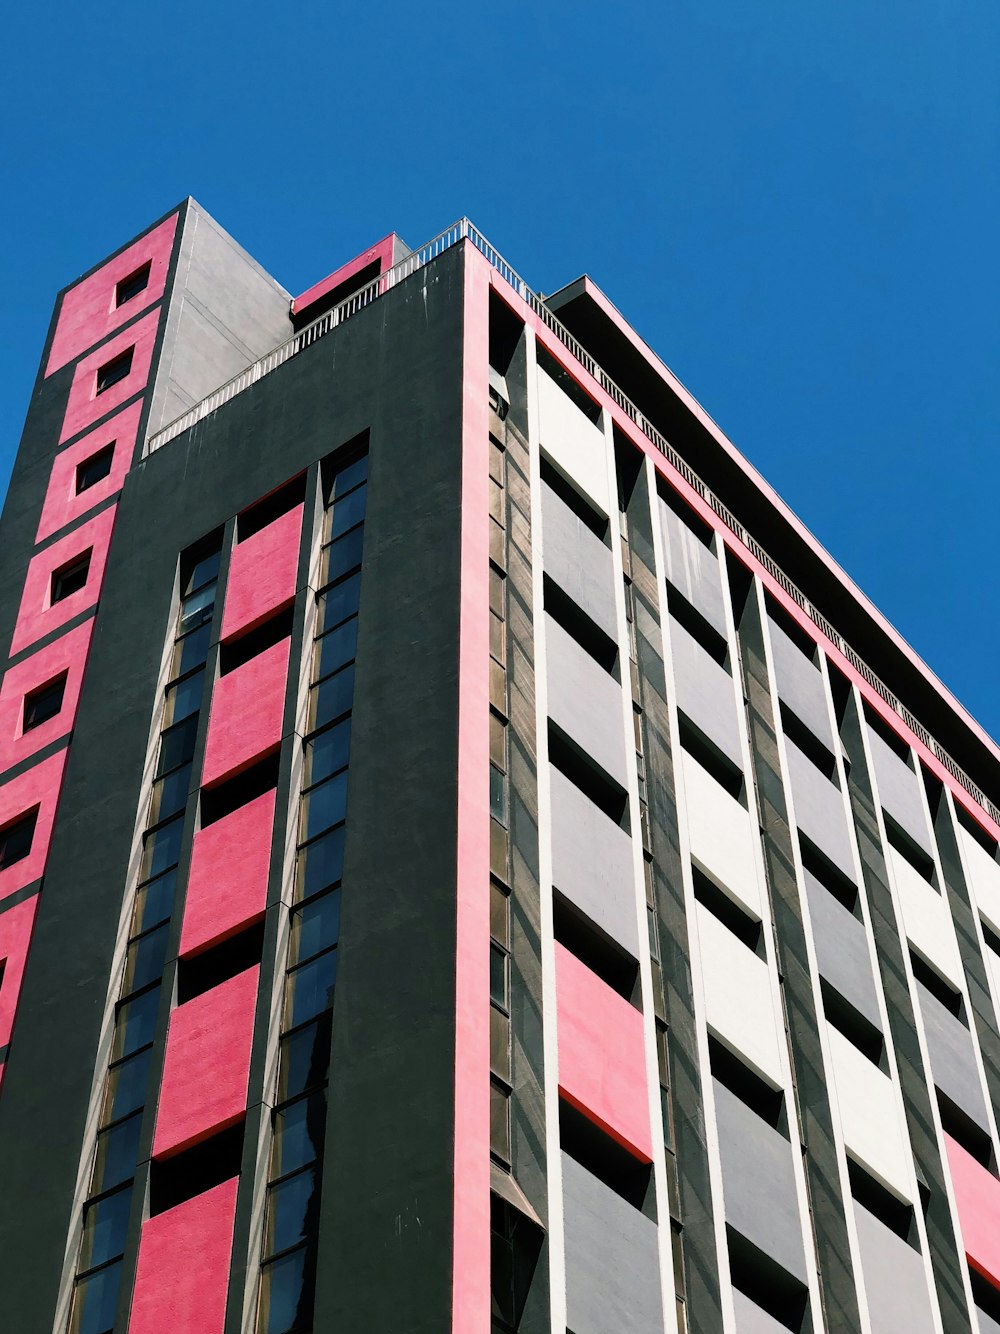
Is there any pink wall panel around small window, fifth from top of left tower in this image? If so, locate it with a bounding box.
[0,618,93,774]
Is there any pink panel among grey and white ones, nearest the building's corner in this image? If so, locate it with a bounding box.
[556,943,653,1163]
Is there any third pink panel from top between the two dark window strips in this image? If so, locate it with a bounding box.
[180,788,275,958]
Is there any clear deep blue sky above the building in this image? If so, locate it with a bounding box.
[0,0,1000,736]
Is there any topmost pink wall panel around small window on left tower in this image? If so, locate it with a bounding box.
[45,213,177,375]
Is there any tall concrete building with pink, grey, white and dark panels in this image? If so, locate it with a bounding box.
[0,200,1000,1334]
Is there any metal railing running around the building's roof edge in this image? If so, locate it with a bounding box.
[145,217,1000,824]
